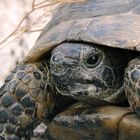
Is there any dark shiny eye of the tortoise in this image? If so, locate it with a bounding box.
[84,54,101,68]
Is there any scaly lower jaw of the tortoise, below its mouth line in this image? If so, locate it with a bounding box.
[55,82,111,101]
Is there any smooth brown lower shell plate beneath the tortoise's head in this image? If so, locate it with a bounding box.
[46,102,133,140]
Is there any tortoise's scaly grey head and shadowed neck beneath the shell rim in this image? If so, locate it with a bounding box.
[50,43,128,104]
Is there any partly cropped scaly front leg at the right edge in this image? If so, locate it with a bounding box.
[124,57,140,115]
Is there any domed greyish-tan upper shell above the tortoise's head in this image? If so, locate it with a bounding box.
[24,0,140,62]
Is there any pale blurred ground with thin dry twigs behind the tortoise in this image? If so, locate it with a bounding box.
[0,0,59,86]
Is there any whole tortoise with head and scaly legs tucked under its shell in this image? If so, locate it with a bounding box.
[0,0,140,140]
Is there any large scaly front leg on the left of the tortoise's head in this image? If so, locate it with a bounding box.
[0,63,54,140]
